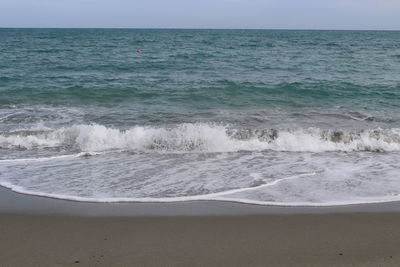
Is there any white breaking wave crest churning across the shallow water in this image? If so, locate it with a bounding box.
[0,123,400,152]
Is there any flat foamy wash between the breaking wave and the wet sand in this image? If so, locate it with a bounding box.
[0,146,400,206]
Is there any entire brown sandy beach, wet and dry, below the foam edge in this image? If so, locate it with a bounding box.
[0,188,400,267]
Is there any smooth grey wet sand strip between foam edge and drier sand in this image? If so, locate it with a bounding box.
[0,187,400,217]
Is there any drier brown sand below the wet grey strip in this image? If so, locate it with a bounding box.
[0,213,400,266]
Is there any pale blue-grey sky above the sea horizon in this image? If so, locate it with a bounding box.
[0,0,400,30]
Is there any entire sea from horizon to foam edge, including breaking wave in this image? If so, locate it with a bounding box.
[0,29,400,206]
